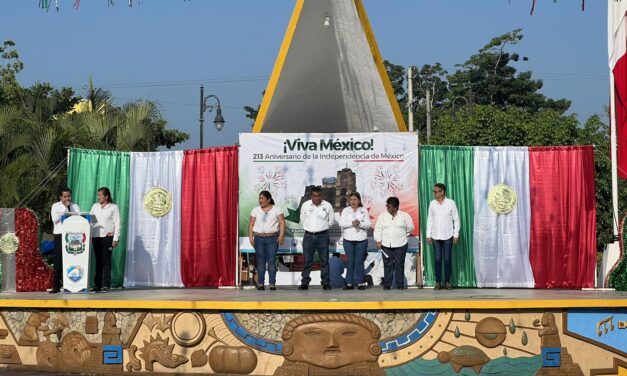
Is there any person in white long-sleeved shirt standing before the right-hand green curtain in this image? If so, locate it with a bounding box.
[427,183,460,290]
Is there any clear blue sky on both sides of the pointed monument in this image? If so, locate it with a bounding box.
[0,0,609,149]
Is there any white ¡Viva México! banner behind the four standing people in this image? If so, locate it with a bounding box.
[239,133,419,253]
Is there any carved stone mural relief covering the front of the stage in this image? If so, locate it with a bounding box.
[0,309,627,376]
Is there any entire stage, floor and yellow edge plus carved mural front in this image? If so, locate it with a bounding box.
[0,286,627,376]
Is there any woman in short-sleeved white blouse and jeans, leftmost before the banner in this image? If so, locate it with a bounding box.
[248,191,285,290]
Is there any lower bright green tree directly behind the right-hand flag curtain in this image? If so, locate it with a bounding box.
[431,105,627,252]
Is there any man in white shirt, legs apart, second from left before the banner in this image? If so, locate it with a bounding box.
[298,187,335,290]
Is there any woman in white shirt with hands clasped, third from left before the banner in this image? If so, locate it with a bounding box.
[340,192,370,290]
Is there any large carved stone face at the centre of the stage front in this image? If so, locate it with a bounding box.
[285,321,381,368]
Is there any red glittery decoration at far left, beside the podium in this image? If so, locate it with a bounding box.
[15,208,54,292]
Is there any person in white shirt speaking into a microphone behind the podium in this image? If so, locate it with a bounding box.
[49,188,80,294]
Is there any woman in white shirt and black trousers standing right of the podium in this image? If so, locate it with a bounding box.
[91,187,120,292]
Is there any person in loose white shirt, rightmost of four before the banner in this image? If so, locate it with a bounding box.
[373,197,414,290]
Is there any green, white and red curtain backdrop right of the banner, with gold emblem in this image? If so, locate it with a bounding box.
[419,146,596,288]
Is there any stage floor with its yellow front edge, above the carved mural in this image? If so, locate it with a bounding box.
[0,286,627,311]
